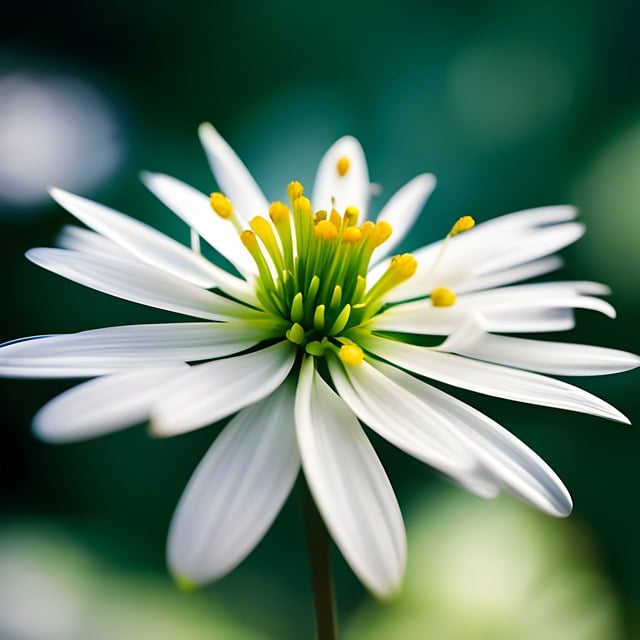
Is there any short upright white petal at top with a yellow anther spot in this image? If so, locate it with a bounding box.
[311,136,371,222]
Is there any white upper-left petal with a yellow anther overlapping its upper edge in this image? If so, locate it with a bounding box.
[141,172,257,276]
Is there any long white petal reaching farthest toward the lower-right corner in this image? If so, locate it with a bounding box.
[375,362,572,516]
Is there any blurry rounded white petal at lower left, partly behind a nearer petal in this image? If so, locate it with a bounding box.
[33,365,186,442]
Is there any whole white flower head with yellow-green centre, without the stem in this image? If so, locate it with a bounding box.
[0,125,639,596]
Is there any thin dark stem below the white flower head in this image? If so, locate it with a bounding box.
[300,476,338,640]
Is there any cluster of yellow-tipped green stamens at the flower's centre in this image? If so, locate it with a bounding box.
[210,172,474,364]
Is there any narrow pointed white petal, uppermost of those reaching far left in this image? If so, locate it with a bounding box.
[50,189,248,296]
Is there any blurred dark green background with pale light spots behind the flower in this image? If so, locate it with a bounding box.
[0,0,640,640]
